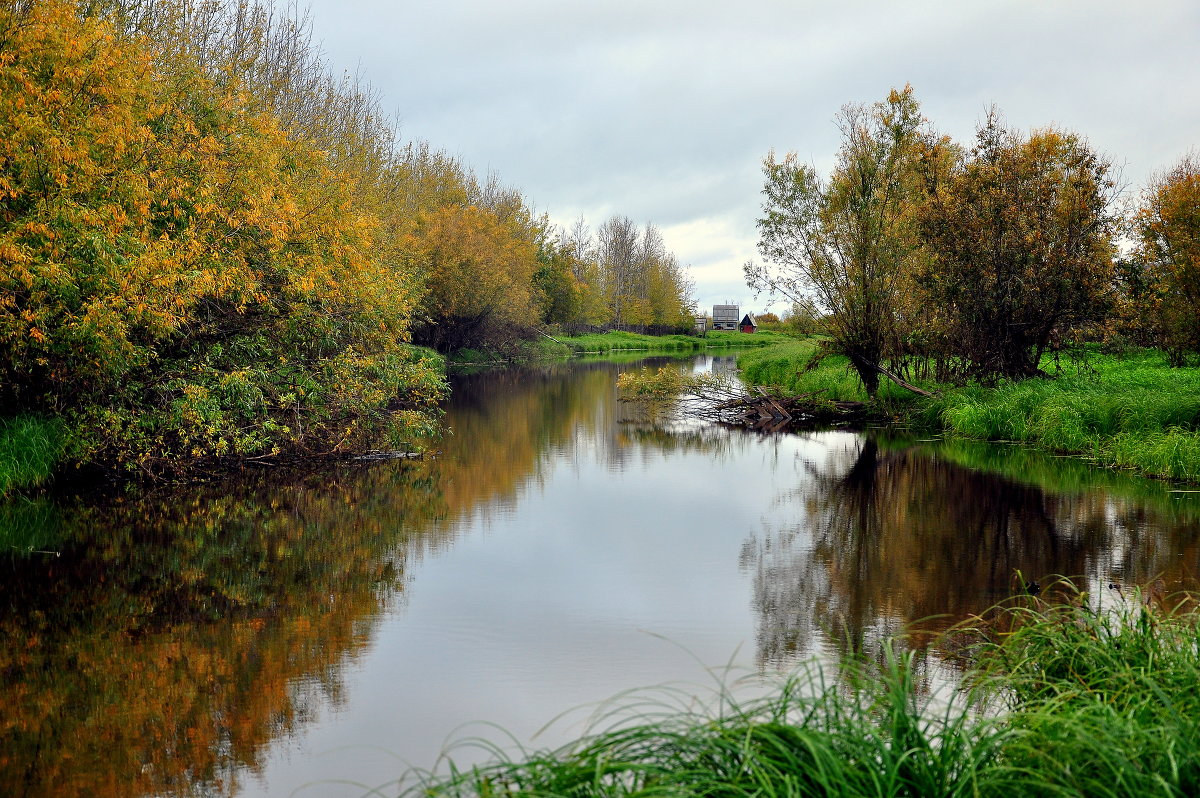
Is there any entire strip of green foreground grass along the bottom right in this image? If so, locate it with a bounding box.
[407,594,1200,798]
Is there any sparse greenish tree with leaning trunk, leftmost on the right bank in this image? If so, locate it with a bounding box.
[745,86,926,396]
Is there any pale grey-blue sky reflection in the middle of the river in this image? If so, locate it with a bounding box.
[251,364,840,794]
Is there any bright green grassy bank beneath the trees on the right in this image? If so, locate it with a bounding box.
[738,338,1200,482]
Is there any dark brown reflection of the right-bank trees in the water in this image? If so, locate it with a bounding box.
[743,438,1198,667]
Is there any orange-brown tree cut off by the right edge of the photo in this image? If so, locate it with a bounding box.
[1132,154,1200,365]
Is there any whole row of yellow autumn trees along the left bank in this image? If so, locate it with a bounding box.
[0,0,691,474]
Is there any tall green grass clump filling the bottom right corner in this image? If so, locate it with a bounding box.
[977,583,1200,796]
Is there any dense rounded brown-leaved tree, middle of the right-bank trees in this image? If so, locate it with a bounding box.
[919,113,1116,382]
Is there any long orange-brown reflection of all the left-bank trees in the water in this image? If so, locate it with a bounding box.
[0,355,729,796]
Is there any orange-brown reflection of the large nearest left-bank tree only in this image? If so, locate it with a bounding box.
[0,460,439,796]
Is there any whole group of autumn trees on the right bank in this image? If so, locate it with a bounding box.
[745,86,1200,394]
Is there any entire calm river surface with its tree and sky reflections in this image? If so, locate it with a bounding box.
[0,361,1200,796]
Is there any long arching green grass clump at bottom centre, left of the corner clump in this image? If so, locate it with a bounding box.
[409,658,996,798]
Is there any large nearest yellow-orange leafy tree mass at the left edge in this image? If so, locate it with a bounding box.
[0,0,440,472]
